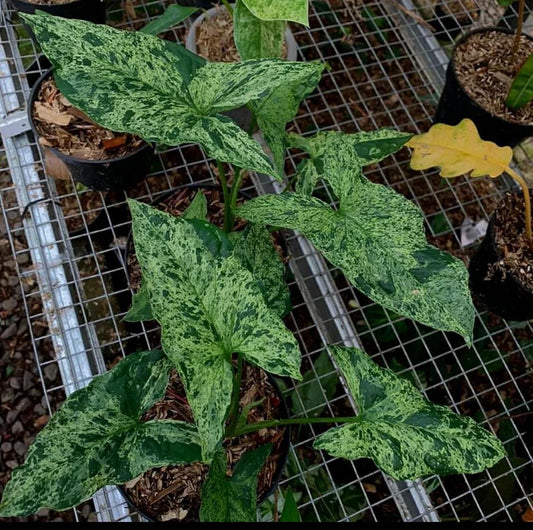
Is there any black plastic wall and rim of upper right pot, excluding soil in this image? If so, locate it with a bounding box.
[433,27,533,147]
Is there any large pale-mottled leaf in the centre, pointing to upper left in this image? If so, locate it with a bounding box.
[129,200,301,459]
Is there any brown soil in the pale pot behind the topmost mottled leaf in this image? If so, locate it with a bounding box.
[196,7,287,63]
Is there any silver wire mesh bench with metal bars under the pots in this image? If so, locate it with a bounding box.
[0,0,533,522]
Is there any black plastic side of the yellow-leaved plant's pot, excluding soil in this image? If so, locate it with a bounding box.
[468,191,533,321]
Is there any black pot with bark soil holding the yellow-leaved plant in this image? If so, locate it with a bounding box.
[468,193,533,321]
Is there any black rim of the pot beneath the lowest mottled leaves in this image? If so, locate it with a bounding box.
[118,366,291,523]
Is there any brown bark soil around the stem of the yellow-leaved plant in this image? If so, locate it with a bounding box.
[489,193,533,291]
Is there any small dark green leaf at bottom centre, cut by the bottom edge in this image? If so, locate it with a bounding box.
[200,444,272,523]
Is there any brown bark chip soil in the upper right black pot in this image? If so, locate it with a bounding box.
[454,31,533,124]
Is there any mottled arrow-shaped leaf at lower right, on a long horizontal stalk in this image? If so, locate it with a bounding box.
[314,346,505,480]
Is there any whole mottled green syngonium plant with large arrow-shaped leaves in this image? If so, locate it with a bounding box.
[0,13,505,521]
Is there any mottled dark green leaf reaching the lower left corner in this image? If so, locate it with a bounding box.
[0,351,201,517]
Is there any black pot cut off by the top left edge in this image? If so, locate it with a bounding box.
[7,0,106,44]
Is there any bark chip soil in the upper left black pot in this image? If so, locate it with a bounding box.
[32,78,143,160]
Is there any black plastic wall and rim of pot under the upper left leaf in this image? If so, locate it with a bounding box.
[27,69,154,191]
